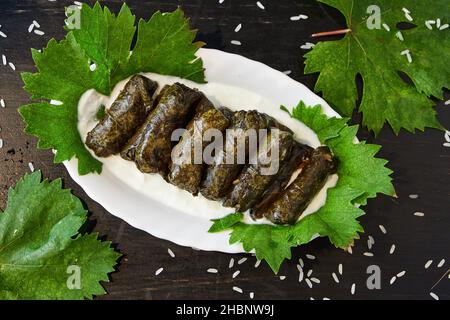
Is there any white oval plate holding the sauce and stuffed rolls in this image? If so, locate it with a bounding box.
[64,49,339,253]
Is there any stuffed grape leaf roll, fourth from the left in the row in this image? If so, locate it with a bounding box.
[200,111,270,200]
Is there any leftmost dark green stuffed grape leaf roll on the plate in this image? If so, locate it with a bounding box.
[86,75,158,157]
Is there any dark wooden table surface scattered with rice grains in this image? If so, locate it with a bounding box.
[0,0,450,299]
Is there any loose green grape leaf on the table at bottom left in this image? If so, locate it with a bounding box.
[0,171,120,299]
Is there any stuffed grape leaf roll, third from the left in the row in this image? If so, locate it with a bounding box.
[168,97,229,195]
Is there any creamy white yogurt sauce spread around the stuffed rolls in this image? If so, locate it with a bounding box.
[78,73,338,224]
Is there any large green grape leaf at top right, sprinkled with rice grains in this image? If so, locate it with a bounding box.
[305,0,450,134]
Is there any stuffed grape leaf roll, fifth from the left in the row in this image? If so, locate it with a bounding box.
[223,129,295,212]
